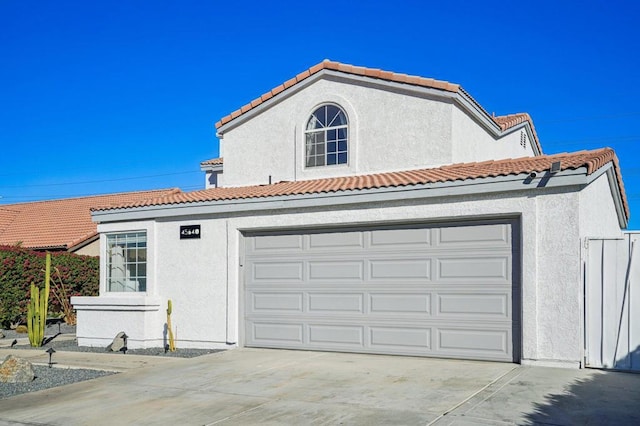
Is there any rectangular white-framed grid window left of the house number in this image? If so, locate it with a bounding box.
[104,230,149,294]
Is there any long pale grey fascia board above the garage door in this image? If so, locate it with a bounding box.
[92,167,588,223]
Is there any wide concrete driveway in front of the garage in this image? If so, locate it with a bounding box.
[0,349,640,425]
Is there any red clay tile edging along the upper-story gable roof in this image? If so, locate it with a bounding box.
[216,59,542,152]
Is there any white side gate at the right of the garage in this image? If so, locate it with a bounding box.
[585,233,640,371]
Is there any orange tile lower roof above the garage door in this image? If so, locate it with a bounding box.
[92,148,629,218]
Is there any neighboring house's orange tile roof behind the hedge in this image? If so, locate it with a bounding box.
[0,188,180,249]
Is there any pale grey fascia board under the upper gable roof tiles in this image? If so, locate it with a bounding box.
[216,69,502,138]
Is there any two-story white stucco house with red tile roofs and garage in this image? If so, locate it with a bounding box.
[73,61,629,366]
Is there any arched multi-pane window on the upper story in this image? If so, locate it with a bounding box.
[305,104,348,167]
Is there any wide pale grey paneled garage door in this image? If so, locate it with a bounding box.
[243,221,520,361]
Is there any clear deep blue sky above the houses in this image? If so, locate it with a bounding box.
[0,0,640,229]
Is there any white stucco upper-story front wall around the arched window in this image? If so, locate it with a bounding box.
[224,79,452,186]
